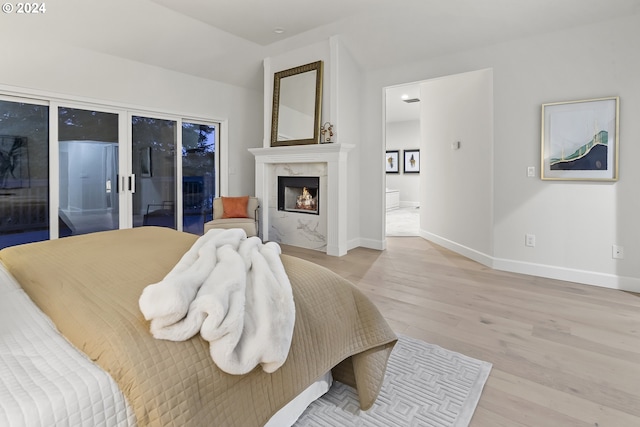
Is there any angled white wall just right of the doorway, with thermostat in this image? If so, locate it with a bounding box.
[420,70,493,262]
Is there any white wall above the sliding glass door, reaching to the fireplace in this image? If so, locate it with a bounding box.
[0,38,262,195]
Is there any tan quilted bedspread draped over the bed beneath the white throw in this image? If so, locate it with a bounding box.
[0,227,396,427]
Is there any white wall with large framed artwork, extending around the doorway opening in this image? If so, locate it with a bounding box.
[360,15,640,291]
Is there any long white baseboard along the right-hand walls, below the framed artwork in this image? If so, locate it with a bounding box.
[420,230,640,293]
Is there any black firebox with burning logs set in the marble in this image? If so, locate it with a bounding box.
[278,176,320,215]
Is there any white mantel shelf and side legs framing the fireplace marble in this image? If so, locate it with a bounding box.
[249,143,355,256]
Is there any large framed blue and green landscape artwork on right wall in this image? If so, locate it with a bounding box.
[541,97,619,181]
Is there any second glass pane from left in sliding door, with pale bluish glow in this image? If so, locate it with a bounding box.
[58,107,119,237]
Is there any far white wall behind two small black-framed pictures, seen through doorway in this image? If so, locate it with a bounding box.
[386,120,420,207]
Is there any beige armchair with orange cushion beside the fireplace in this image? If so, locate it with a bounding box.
[204,196,260,237]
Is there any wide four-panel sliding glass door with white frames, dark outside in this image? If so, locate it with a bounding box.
[0,95,220,248]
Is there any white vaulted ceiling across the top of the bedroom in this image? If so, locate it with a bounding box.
[6,0,640,94]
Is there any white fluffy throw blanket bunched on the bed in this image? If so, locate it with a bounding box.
[139,229,295,375]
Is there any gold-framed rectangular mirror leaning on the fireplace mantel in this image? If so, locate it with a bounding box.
[271,61,323,147]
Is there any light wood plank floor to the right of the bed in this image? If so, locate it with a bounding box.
[282,237,640,427]
